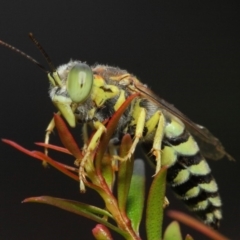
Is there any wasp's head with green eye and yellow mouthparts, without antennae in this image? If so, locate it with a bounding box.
[48,61,93,127]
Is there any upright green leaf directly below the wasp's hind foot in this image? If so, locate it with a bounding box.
[146,167,167,240]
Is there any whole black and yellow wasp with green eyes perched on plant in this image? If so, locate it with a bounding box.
[0,34,232,228]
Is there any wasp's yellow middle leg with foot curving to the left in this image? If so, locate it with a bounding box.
[114,108,146,161]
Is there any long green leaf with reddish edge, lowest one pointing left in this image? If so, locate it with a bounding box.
[23,196,125,236]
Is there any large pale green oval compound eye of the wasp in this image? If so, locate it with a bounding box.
[67,63,93,103]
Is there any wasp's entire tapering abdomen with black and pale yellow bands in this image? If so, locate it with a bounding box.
[162,118,222,228]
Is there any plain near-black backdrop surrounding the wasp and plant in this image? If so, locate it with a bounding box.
[0,0,240,240]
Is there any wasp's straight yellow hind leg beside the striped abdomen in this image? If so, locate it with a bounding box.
[151,111,165,173]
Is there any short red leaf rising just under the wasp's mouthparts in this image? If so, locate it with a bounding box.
[54,114,82,159]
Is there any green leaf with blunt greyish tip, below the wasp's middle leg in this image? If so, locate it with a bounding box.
[127,159,145,233]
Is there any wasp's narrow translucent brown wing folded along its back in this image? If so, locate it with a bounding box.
[133,80,234,160]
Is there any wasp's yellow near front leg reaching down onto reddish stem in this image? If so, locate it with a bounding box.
[75,121,106,192]
